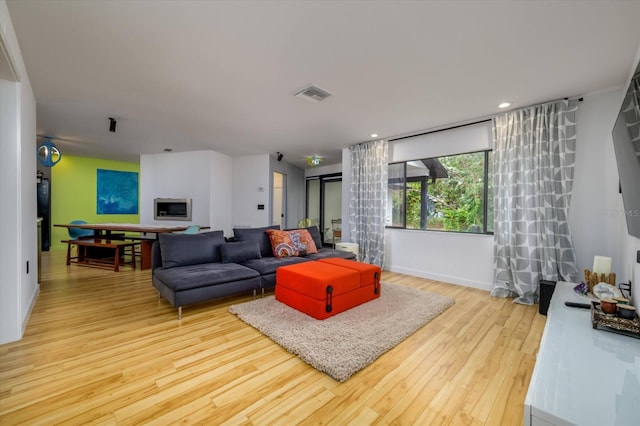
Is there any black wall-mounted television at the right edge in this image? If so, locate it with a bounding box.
[612,64,640,238]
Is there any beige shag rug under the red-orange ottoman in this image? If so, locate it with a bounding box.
[229,283,455,382]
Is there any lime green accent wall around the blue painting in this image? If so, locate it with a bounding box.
[51,155,140,250]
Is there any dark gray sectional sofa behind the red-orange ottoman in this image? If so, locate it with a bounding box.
[151,226,355,319]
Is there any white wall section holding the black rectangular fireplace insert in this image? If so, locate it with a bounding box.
[140,151,231,235]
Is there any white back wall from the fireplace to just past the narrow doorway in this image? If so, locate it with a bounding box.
[140,151,305,237]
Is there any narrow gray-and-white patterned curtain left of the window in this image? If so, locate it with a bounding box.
[349,140,389,268]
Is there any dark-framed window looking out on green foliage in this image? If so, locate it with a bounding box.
[388,151,493,233]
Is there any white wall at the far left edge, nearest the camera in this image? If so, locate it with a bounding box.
[0,0,40,344]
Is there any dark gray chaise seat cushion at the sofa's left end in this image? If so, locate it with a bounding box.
[153,263,260,291]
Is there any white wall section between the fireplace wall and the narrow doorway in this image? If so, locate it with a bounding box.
[231,154,273,228]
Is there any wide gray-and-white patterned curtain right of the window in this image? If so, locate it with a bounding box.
[491,101,578,305]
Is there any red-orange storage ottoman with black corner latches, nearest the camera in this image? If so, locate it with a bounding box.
[276,262,380,320]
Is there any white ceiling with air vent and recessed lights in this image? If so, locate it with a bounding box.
[7,0,640,167]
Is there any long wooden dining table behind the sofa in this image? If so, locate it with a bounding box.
[53,223,210,269]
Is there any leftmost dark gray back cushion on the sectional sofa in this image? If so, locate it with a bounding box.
[158,231,224,268]
